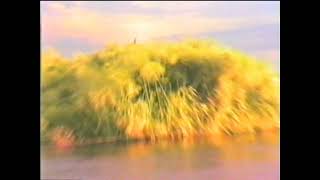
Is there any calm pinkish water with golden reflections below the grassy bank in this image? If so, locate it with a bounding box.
[41,136,280,180]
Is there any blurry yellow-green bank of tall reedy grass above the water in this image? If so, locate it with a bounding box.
[41,40,280,146]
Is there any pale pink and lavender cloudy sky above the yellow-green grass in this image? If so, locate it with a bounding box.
[41,1,280,71]
